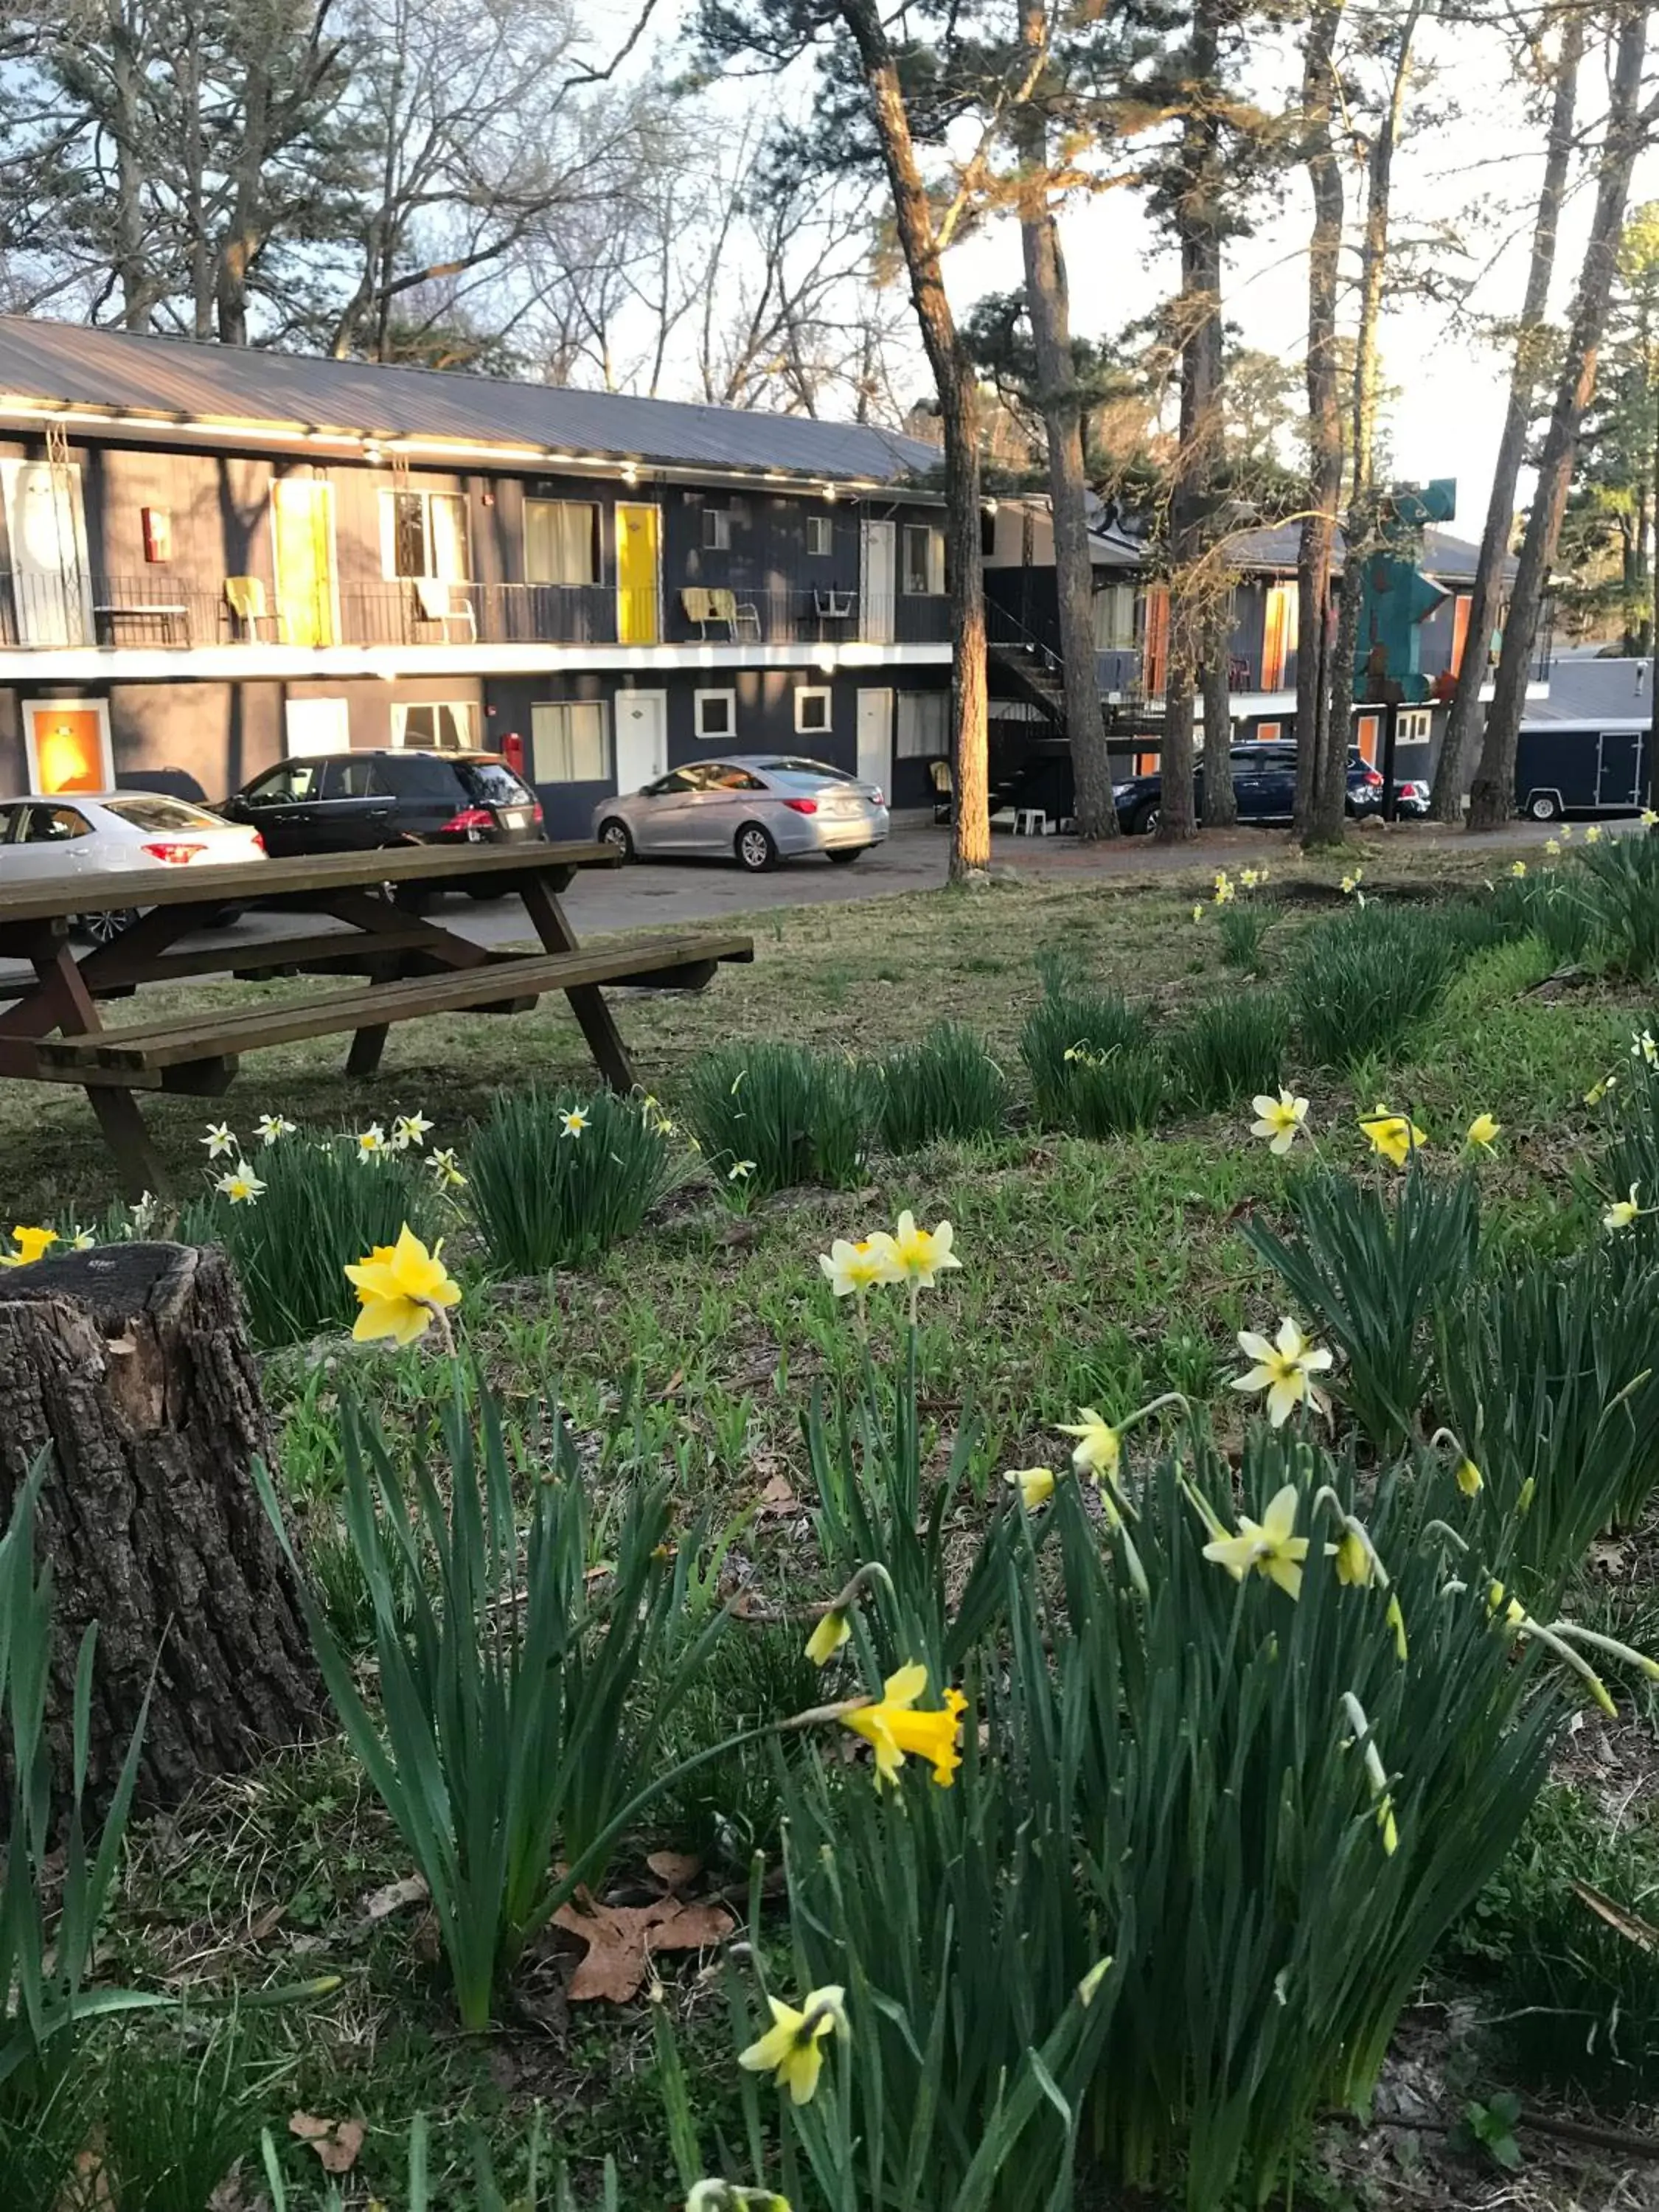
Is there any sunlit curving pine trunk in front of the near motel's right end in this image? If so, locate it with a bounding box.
[836,0,991,883]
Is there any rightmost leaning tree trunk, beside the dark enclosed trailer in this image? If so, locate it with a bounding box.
[1469,4,1648,830]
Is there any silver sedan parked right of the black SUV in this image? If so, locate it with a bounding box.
[593,752,887,874]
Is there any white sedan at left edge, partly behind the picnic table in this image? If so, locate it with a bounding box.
[0,792,265,938]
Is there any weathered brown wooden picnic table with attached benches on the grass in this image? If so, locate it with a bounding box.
[0,843,754,1199]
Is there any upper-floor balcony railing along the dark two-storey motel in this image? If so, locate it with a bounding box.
[0,568,951,650]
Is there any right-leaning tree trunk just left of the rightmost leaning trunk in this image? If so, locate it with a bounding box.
[1429,7,1584,823]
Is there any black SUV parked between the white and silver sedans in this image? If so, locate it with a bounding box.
[219,750,544,867]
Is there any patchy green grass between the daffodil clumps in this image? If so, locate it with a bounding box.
[0,849,1659,2212]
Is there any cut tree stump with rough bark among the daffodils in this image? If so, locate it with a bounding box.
[0,1243,325,1805]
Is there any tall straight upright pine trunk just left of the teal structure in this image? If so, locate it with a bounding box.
[1296,0,1343,838]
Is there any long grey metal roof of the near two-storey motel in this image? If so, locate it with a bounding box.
[0,316,942,484]
